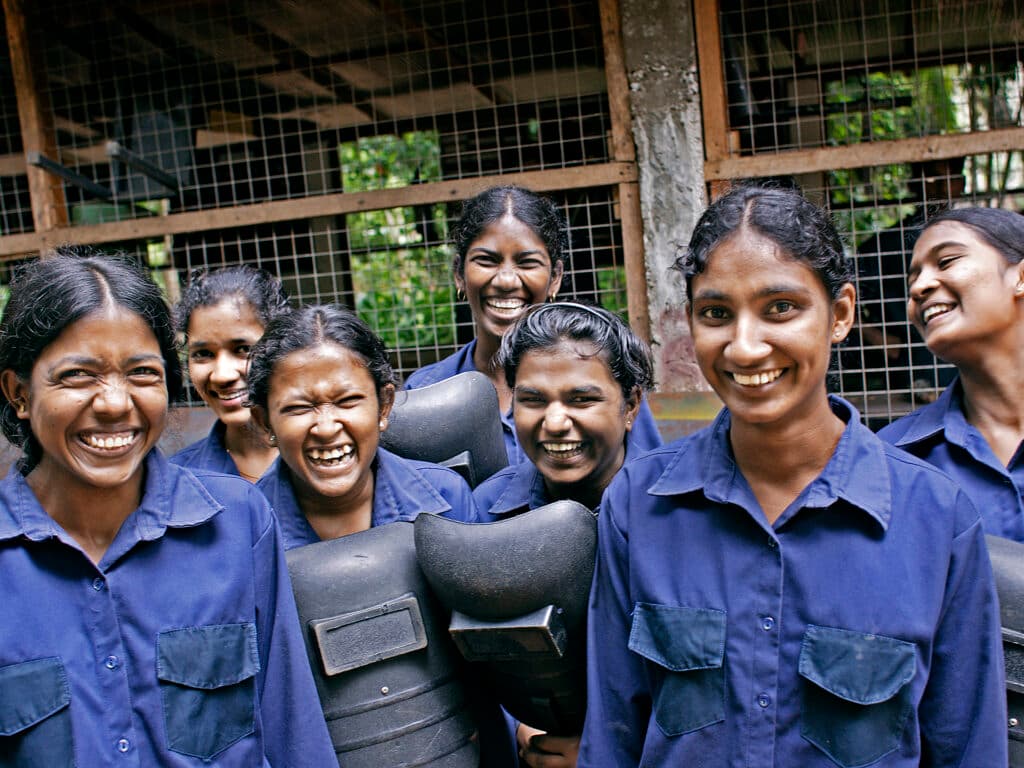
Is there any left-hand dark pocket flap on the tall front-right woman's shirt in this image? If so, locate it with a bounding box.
[630,603,725,672]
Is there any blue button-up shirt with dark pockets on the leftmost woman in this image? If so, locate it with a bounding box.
[0,451,337,768]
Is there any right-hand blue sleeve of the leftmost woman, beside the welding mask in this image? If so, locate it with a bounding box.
[253,501,338,768]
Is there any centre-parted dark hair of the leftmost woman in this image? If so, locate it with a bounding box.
[0,245,182,469]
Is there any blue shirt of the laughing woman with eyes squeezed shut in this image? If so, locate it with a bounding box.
[256,447,478,550]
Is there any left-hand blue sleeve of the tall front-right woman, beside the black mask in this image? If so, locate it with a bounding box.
[578,472,650,768]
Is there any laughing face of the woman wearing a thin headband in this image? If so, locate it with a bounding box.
[512,341,640,498]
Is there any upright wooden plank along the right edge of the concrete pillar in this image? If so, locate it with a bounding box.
[693,0,729,162]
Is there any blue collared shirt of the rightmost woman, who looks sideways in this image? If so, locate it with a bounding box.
[879,379,1024,542]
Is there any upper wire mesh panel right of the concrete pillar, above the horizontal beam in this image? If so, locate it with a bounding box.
[720,0,1024,154]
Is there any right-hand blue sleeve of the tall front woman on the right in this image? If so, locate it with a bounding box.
[920,492,1008,768]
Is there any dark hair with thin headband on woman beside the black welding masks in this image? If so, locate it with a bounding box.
[498,301,654,398]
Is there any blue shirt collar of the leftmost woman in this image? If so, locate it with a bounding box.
[0,449,223,561]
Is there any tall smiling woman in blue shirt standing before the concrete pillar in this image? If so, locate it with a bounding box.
[580,186,1007,768]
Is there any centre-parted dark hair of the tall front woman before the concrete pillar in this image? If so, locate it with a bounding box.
[676,186,854,299]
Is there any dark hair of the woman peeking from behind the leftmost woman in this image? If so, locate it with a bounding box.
[174,264,289,338]
